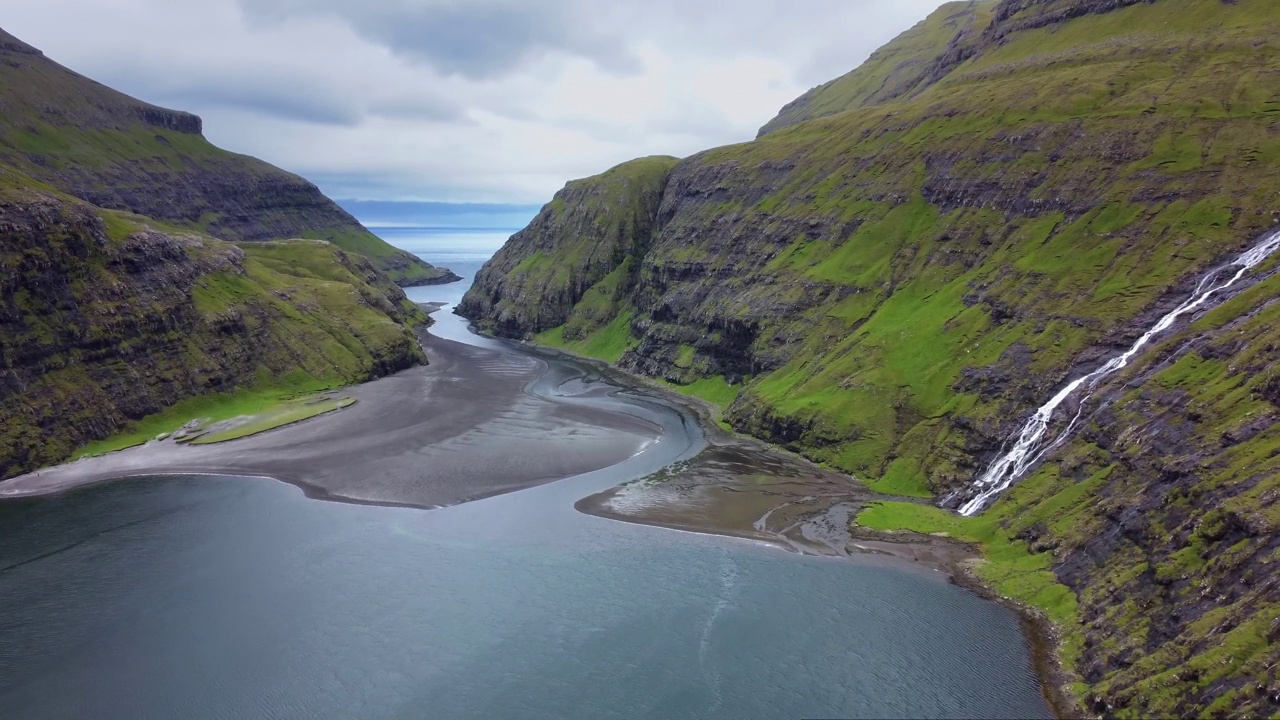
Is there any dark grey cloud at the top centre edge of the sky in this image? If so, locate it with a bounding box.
[239,0,640,79]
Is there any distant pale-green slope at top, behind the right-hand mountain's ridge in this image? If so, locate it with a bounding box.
[759,0,996,136]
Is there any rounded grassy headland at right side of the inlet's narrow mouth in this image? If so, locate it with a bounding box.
[458,158,678,341]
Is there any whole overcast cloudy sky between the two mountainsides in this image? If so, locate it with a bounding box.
[0,0,938,202]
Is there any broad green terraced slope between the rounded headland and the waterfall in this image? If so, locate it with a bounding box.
[650,0,1280,499]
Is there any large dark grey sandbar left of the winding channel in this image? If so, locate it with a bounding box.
[0,336,660,507]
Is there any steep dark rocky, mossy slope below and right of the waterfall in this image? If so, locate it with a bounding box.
[996,263,1280,717]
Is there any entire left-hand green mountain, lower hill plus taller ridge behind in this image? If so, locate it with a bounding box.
[0,36,440,479]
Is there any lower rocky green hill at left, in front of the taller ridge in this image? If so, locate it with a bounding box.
[0,170,428,478]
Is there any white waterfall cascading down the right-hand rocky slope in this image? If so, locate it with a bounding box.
[960,231,1280,515]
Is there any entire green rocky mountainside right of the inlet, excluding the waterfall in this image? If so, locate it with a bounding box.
[462,0,1280,716]
